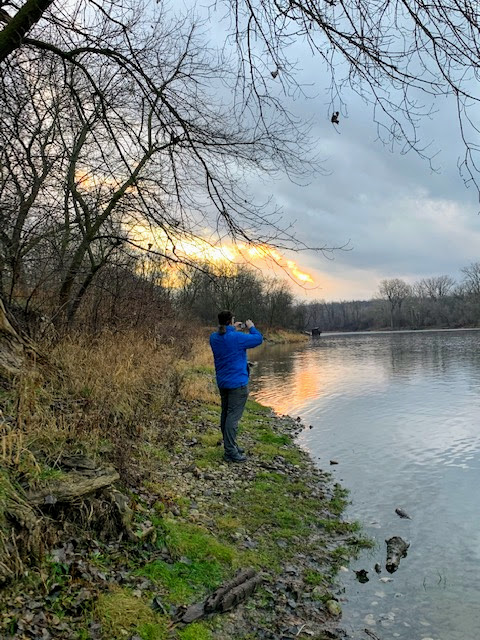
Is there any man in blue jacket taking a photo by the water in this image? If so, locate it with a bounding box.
[210,311,263,462]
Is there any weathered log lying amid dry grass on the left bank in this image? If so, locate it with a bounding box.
[27,468,120,507]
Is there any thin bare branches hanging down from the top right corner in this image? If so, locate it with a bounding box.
[224,0,480,188]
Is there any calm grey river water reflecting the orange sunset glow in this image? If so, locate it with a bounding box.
[251,331,480,640]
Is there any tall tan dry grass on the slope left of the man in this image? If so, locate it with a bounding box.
[0,330,217,476]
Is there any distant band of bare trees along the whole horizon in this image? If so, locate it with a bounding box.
[0,250,480,334]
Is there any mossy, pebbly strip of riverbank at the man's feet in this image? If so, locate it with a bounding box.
[0,402,368,640]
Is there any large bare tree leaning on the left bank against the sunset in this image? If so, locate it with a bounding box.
[0,2,321,323]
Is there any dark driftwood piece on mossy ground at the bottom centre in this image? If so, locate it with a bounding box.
[176,569,263,624]
